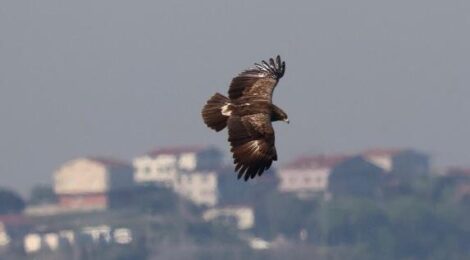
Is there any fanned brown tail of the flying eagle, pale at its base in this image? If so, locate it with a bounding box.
[202,93,230,132]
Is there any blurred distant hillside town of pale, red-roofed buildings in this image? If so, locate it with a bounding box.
[0,146,470,259]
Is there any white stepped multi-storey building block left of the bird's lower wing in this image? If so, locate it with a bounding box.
[133,146,223,206]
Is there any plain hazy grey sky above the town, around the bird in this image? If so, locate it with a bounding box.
[0,0,470,192]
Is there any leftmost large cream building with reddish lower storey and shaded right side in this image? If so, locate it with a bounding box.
[54,157,134,209]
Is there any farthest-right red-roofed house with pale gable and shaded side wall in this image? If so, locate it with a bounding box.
[362,148,430,176]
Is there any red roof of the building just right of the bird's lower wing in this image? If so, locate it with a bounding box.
[283,155,351,169]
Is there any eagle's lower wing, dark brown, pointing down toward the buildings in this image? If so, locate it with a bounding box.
[228,113,277,181]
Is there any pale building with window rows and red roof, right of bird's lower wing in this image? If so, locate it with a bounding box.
[277,155,348,194]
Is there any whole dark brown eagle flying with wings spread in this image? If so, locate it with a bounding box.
[202,55,289,181]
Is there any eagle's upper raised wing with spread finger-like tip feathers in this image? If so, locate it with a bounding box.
[228,55,286,102]
